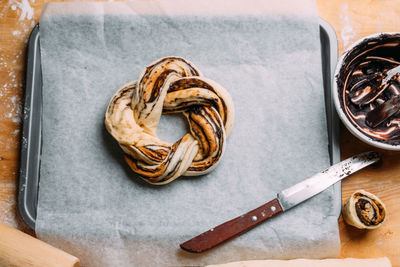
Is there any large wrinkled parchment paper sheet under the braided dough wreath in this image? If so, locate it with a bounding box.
[36,0,340,266]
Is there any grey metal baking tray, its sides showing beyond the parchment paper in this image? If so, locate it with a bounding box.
[18,19,341,229]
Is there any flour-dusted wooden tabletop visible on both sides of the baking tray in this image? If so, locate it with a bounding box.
[0,0,400,267]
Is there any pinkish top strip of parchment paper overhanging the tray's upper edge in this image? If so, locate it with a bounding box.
[41,0,317,19]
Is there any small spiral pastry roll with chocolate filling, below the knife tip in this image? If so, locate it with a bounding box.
[342,190,386,229]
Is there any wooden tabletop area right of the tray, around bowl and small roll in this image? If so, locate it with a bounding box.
[317,0,400,266]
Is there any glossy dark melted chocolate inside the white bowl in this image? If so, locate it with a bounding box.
[337,34,400,145]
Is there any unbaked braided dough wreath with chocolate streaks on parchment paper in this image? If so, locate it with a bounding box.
[105,57,234,185]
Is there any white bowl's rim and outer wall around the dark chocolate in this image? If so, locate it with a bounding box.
[332,32,400,151]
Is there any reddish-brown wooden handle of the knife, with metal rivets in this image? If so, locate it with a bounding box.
[180,198,283,253]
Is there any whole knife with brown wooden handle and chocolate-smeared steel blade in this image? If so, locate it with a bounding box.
[180,151,380,253]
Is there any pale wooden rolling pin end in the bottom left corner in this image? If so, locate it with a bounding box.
[0,223,79,267]
